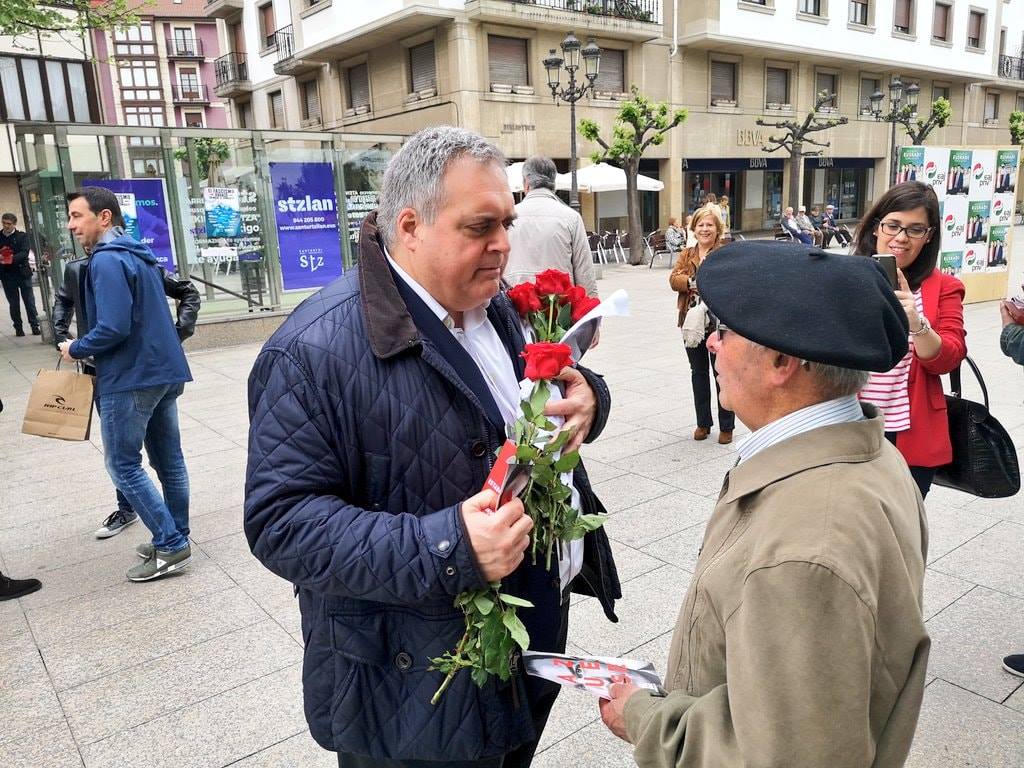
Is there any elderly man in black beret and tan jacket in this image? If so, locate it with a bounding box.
[601,242,930,768]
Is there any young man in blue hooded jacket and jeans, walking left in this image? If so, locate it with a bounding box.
[60,186,191,582]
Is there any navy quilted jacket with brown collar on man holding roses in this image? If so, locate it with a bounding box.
[245,216,621,761]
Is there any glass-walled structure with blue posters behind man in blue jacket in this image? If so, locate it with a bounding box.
[16,124,404,316]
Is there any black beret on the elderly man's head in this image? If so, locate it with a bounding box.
[697,240,909,372]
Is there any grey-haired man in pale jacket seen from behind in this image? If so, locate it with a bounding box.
[505,156,597,296]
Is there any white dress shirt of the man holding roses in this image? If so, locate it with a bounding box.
[384,250,583,592]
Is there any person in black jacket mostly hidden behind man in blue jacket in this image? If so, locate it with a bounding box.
[51,244,201,539]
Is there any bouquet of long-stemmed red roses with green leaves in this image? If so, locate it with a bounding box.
[430,269,604,703]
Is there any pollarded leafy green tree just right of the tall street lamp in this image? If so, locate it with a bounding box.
[580,85,687,264]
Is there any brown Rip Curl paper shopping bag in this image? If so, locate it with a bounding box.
[22,365,93,440]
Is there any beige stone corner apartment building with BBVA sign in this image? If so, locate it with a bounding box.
[206,0,1024,230]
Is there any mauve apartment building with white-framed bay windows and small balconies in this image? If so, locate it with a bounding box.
[92,0,230,176]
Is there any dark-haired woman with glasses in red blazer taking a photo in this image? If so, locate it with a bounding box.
[854,181,967,498]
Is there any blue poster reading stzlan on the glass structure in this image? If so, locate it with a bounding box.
[270,163,342,291]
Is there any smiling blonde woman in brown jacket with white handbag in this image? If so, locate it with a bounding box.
[669,206,735,445]
